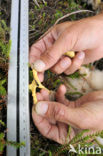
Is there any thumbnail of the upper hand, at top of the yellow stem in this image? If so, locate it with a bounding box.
[33,60,45,72]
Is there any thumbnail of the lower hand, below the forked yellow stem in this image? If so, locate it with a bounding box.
[35,102,48,115]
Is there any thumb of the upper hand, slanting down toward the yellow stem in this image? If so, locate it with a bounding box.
[34,29,76,72]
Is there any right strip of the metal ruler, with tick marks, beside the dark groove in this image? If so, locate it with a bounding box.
[19,0,30,156]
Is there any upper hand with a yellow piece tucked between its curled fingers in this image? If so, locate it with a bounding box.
[30,14,103,74]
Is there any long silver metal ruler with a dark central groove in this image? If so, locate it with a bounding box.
[7,0,30,156]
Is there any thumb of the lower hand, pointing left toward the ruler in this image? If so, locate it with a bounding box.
[35,101,88,129]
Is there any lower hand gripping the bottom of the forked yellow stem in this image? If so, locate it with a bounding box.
[32,85,103,144]
